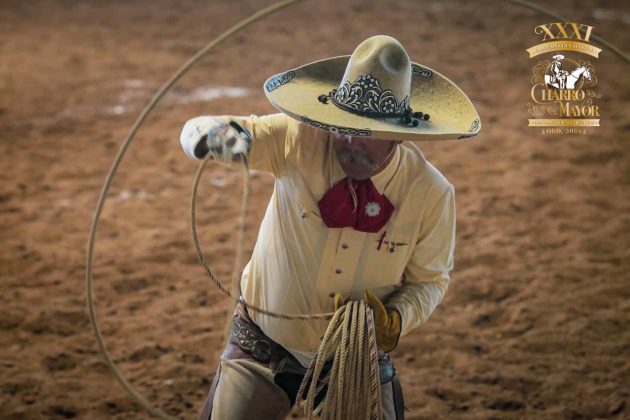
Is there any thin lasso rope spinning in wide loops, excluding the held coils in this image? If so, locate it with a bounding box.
[86,0,630,419]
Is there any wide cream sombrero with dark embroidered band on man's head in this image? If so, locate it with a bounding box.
[264,35,481,141]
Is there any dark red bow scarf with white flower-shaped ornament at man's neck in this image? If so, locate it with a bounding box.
[319,177,394,233]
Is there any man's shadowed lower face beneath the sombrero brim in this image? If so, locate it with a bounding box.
[333,133,401,180]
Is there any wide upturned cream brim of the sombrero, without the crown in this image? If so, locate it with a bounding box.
[264,55,481,141]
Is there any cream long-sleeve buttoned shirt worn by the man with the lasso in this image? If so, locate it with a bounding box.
[181,114,455,366]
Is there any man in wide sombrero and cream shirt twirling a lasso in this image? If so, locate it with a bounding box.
[180,35,480,420]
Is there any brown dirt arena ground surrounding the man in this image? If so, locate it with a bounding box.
[0,0,630,419]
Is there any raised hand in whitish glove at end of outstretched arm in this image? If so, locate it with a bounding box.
[179,117,252,162]
